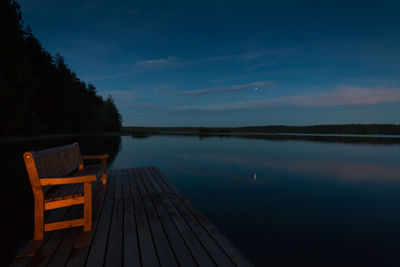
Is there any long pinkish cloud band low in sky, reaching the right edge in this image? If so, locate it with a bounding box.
[181,86,400,111]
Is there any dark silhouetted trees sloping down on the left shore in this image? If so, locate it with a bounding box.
[0,0,122,136]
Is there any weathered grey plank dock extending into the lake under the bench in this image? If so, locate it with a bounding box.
[11,167,253,266]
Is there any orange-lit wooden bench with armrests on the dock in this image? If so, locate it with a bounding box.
[23,143,108,240]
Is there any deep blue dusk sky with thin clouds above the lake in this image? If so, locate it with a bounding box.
[19,0,400,126]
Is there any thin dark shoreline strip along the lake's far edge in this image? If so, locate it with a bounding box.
[0,124,400,142]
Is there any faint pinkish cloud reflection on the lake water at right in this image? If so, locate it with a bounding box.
[188,154,400,183]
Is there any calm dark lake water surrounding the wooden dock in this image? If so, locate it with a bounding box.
[0,135,400,266]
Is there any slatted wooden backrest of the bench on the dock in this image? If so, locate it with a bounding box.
[23,143,82,197]
